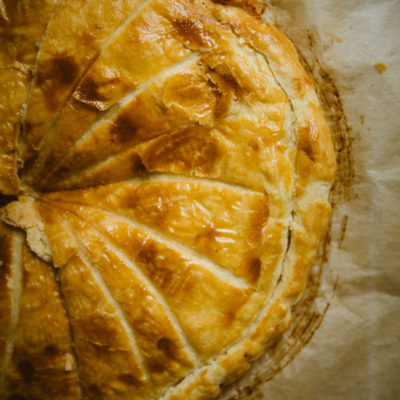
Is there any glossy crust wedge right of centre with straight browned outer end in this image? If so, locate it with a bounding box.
[43,180,272,287]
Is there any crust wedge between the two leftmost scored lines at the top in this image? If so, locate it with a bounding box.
[22,0,145,161]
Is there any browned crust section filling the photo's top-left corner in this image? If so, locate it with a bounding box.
[0,0,56,194]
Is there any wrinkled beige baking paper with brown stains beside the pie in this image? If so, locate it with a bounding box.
[222,0,400,400]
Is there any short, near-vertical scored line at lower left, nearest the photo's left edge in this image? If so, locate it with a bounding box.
[0,231,23,390]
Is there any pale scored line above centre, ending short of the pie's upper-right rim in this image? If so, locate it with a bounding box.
[31,53,200,187]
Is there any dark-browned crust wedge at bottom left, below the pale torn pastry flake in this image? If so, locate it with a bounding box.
[0,239,80,400]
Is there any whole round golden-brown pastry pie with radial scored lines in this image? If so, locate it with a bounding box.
[0,0,335,400]
